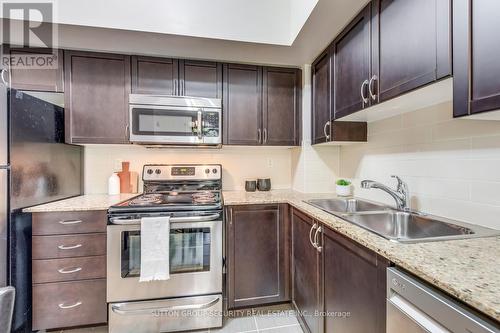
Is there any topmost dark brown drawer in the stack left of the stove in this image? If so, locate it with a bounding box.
[32,210,108,235]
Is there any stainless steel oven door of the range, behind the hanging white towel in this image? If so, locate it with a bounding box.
[107,213,222,302]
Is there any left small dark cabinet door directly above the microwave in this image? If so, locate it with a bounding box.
[132,56,179,95]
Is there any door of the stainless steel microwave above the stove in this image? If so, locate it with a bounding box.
[130,104,203,144]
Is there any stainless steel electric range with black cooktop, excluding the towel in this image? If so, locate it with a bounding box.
[107,165,223,333]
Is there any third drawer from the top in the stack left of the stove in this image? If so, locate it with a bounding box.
[32,256,106,283]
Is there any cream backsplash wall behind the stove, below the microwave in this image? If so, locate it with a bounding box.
[84,145,292,194]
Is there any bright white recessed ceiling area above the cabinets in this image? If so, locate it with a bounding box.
[49,0,318,45]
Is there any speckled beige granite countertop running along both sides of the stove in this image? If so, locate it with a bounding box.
[24,190,500,321]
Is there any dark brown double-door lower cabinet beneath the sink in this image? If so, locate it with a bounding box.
[292,210,389,333]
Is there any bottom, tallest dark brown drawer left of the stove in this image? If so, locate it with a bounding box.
[33,279,107,330]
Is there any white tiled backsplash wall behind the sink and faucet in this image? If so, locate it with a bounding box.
[340,103,500,229]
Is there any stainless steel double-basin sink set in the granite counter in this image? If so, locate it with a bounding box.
[305,198,500,243]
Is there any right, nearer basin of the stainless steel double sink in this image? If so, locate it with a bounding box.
[346,211,476,242]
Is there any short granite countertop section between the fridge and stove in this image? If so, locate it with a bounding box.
[23,194,137,213]
